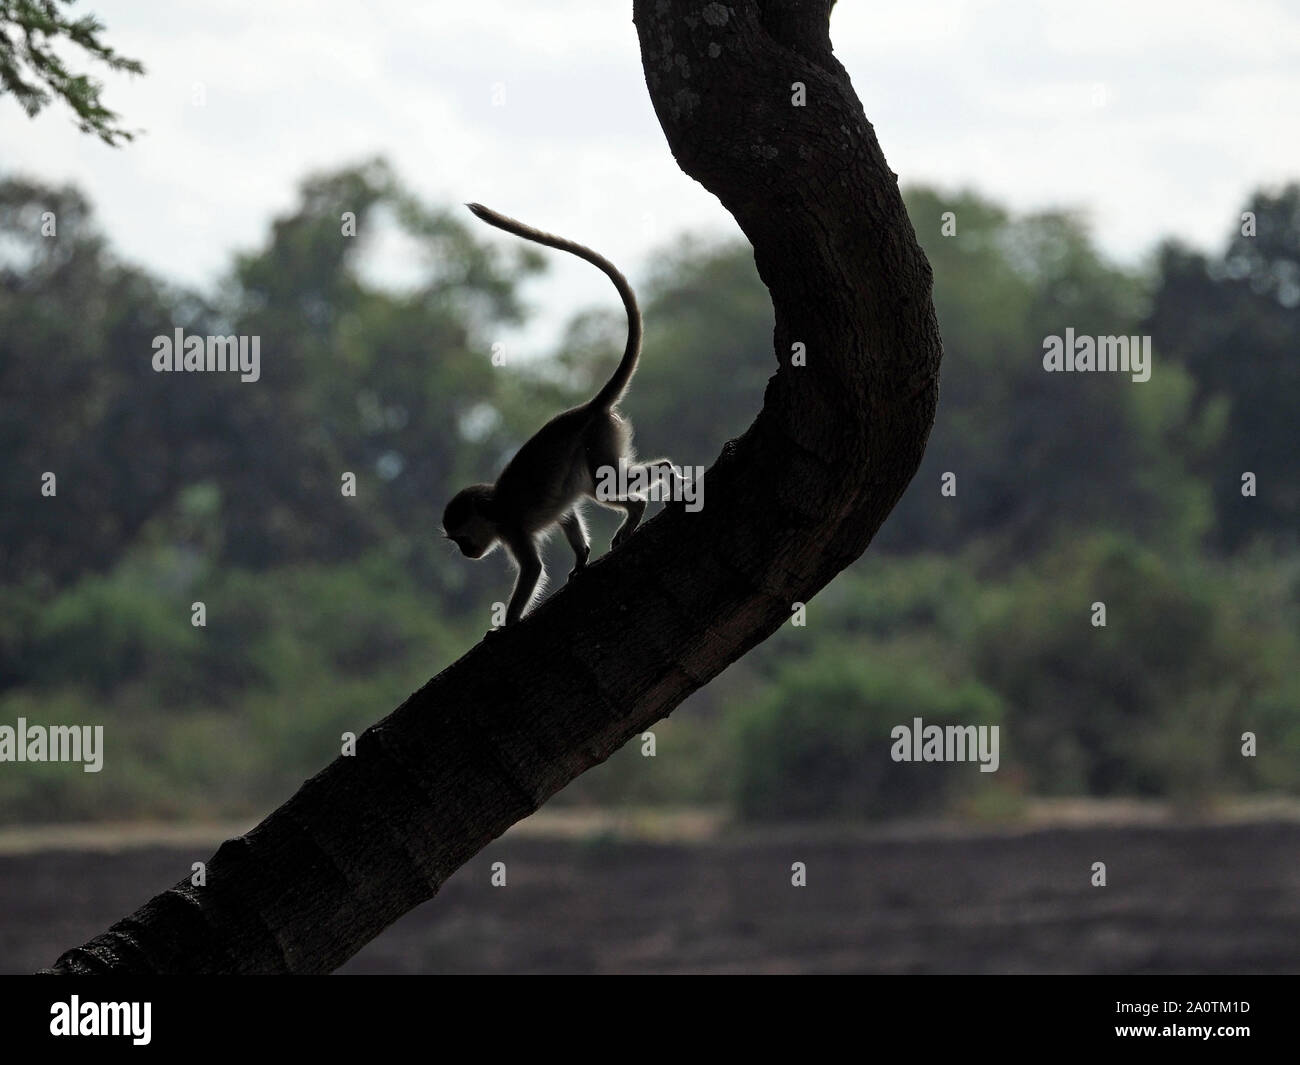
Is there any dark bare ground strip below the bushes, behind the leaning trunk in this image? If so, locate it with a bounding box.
[0,822,1300,973]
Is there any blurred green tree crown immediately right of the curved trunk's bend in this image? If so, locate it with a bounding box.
[876,189,1214,559]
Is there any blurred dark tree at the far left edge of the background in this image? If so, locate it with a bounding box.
[0,179,188,593]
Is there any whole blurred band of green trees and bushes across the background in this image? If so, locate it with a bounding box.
[0,161,1300,821]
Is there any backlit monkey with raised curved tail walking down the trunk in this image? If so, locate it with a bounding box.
[442,203,677,625]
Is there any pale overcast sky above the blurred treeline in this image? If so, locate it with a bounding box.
[0,0,1300,347]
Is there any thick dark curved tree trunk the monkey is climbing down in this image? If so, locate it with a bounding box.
[55,0,941,973]
